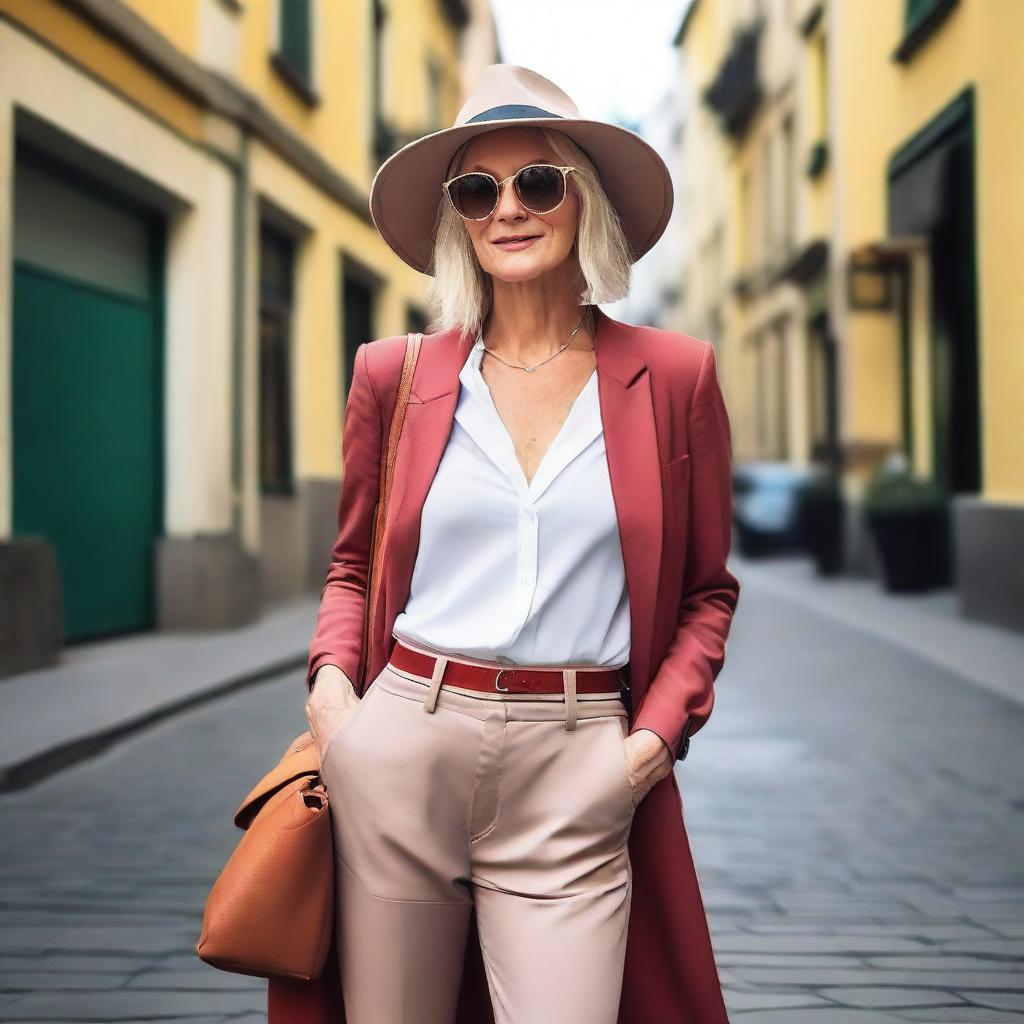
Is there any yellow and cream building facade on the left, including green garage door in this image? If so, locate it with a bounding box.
[0,0,500,672]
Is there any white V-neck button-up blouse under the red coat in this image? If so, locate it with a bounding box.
[393,327,630,668]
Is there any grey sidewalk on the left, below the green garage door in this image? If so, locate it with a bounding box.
[0,595,319,792]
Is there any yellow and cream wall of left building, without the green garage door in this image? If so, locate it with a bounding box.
[0,0,498,672]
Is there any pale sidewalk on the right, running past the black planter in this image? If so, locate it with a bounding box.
[729,554,1024,703]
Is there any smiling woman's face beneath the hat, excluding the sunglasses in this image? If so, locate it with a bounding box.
[453,127,580,282]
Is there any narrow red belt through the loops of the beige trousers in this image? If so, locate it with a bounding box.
[389,638,629,693]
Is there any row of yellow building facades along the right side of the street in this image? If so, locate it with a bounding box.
[677,0,1024,629]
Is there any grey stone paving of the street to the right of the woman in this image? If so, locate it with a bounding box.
[678,584,1024,1024]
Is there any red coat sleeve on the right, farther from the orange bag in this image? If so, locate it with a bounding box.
[632,342,739,761]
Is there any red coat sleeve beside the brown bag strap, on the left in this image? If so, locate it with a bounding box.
[306,343,384,689]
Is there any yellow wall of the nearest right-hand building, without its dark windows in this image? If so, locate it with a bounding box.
[831,0,1024,502]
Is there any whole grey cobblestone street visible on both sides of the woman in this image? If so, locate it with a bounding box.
[0,584,1024,1024]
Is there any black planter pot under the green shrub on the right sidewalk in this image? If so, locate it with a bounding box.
[866,508,951,593]
